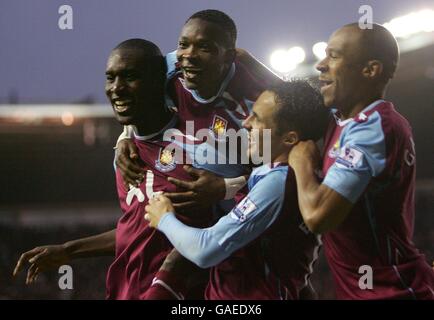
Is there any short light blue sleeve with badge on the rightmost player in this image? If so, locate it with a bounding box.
[323,112,386,203]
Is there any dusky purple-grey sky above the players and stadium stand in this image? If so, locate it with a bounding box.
[0,0,434,103]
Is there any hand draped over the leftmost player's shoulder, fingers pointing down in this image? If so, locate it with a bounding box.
[116,139,145,190]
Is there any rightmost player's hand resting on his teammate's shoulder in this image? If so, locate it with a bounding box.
[288,140,321,168]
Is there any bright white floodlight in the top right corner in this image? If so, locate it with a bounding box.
[384,9,434,38]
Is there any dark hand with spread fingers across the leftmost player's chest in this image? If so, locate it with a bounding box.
[164,165,226,212]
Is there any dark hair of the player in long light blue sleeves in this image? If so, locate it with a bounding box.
[267,79,330,141]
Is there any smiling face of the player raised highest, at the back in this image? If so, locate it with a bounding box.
[176,18,235,98]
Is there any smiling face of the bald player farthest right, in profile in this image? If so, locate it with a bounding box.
[317,27,365,109]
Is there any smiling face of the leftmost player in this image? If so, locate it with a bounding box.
[105,49,155,125]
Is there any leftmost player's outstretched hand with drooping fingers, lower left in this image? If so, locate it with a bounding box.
[12,245,71,284]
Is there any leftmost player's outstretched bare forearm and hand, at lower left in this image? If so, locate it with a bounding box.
[13,229,116,284]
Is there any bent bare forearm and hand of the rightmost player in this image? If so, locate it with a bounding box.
[288,141,353,233]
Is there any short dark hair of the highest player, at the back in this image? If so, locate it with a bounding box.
[185,9,237,49]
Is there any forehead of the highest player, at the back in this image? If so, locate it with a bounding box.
[179,18,225,43]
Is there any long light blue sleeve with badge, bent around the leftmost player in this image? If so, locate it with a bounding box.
[158,170,286,268]
